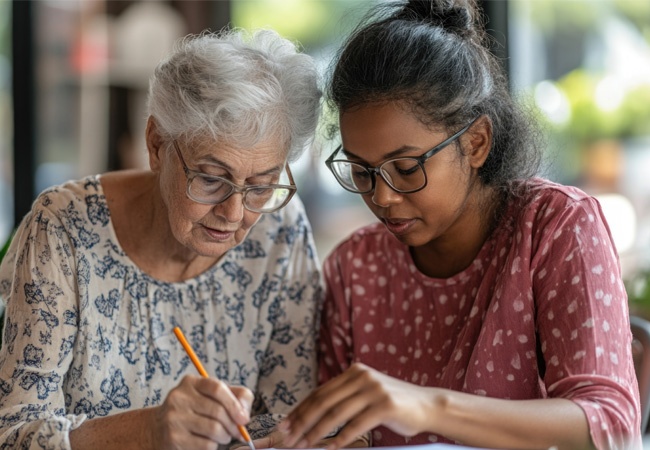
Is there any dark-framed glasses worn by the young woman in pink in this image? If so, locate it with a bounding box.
[325,119,476,194]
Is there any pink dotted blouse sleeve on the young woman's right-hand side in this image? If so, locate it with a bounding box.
[532,197,640,448]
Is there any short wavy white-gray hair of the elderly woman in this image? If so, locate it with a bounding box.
[147,29,321,161]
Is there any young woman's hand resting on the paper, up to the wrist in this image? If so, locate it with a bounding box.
[278,363,434,449]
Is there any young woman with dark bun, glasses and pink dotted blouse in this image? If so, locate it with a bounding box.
[280,0,640,449]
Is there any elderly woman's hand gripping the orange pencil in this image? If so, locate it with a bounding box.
[151,375,253,450]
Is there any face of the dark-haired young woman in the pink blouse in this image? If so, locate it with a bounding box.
[340,103,474,247]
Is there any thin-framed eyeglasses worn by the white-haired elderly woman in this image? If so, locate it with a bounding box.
[173,140,297,213]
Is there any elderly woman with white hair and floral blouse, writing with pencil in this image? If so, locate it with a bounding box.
[0,31,321,450]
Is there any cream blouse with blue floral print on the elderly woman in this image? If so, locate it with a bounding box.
[0,176,321,449]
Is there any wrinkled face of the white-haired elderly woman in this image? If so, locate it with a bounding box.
[154,134,286,258]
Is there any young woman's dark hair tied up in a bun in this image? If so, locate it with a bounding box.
[328,0,542,197]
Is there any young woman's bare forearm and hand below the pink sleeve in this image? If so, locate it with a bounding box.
[285,363,591,450]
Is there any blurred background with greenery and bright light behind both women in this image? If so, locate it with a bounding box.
[0,0,650,304]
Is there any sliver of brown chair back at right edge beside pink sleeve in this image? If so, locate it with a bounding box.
[630,316,650,434]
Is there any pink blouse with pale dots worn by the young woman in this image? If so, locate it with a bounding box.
[320,179,640,449]
